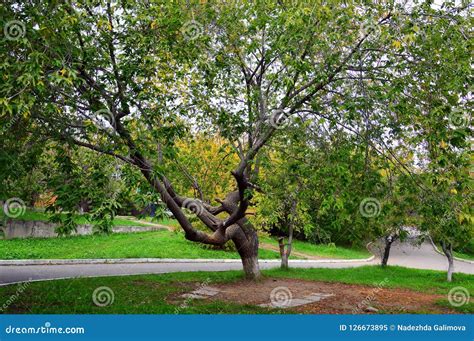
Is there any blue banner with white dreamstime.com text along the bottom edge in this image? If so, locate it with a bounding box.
[0,315,474,341]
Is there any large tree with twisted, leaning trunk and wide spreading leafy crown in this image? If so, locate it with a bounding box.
[1,0,467,278]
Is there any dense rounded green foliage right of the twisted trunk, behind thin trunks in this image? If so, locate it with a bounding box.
[257,129,413,246]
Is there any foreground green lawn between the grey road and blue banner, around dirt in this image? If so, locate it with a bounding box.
[0,266,474,314]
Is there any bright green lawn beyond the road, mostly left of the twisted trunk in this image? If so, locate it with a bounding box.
[0,230,279,259]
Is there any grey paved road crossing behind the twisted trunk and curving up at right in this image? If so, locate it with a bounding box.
[0,243,474,285]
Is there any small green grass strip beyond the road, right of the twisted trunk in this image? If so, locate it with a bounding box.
[260,236,371,259]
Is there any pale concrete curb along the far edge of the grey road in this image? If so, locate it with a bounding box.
[0,256,375,266]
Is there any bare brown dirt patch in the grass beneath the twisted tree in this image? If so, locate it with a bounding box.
[174,278,457,314]
